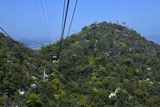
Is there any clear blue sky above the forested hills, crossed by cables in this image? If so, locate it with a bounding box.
[0,0,160,44]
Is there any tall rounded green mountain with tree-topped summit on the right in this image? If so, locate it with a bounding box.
[40,22,160,107]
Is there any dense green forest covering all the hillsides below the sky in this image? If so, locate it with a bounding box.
[0,22,160,107]
